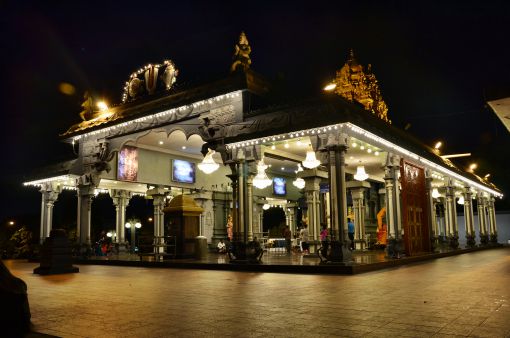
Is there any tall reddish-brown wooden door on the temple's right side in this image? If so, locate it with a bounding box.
[400,160,430,256]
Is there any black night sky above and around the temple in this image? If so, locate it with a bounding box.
[0,1,510,221]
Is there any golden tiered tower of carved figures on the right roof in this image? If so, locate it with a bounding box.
[334,49,391,123]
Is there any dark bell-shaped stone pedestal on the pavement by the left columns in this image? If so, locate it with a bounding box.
[34,229,80,275]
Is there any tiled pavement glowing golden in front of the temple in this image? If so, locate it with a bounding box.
[6,248,510,337]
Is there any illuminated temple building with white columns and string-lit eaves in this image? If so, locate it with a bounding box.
[25,33,502,261]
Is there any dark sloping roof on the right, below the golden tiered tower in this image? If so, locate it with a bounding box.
[225,94,500,191]
